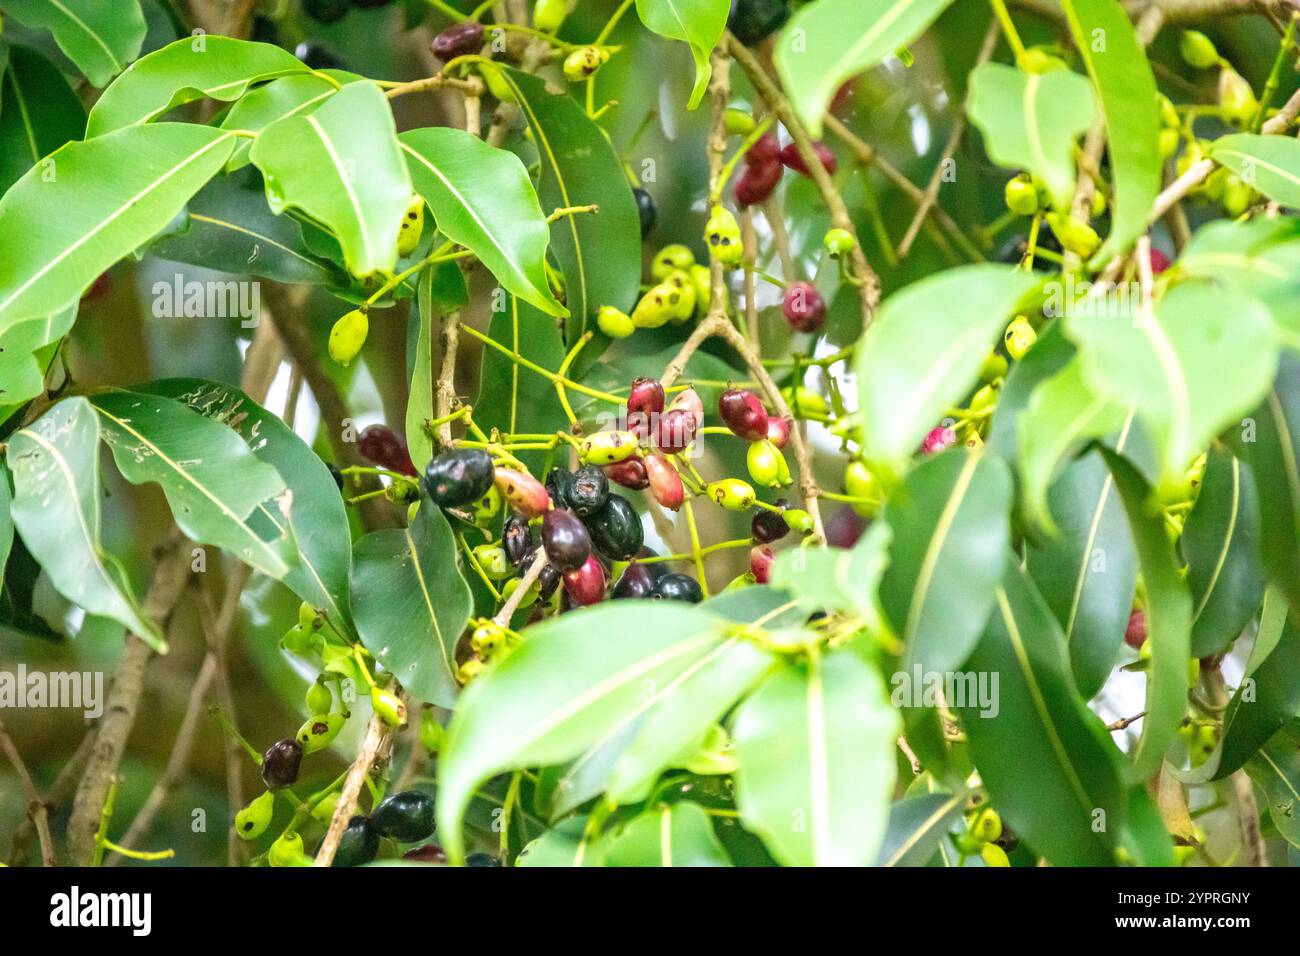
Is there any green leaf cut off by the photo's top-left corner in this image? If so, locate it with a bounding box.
[4,0,146,86]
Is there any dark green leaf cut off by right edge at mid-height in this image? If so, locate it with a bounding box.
[1234,355,1300,607]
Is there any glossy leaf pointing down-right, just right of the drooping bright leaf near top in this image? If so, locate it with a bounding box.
[399,126,568,316]
